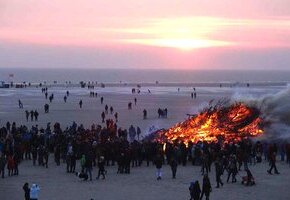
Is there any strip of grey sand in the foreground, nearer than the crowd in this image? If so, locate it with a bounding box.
[0,157,290,200]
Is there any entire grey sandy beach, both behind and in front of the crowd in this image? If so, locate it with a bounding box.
[0,87,290,200]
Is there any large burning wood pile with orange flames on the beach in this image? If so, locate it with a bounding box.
[154,100,263,144]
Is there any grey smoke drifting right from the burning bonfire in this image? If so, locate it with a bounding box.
[231,85,290,141]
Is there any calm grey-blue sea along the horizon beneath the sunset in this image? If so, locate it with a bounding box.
[0,68,290,86]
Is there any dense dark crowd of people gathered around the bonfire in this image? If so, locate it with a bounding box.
[0,119,290,199]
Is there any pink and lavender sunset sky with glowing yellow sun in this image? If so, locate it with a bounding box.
[0,0,290,70]
